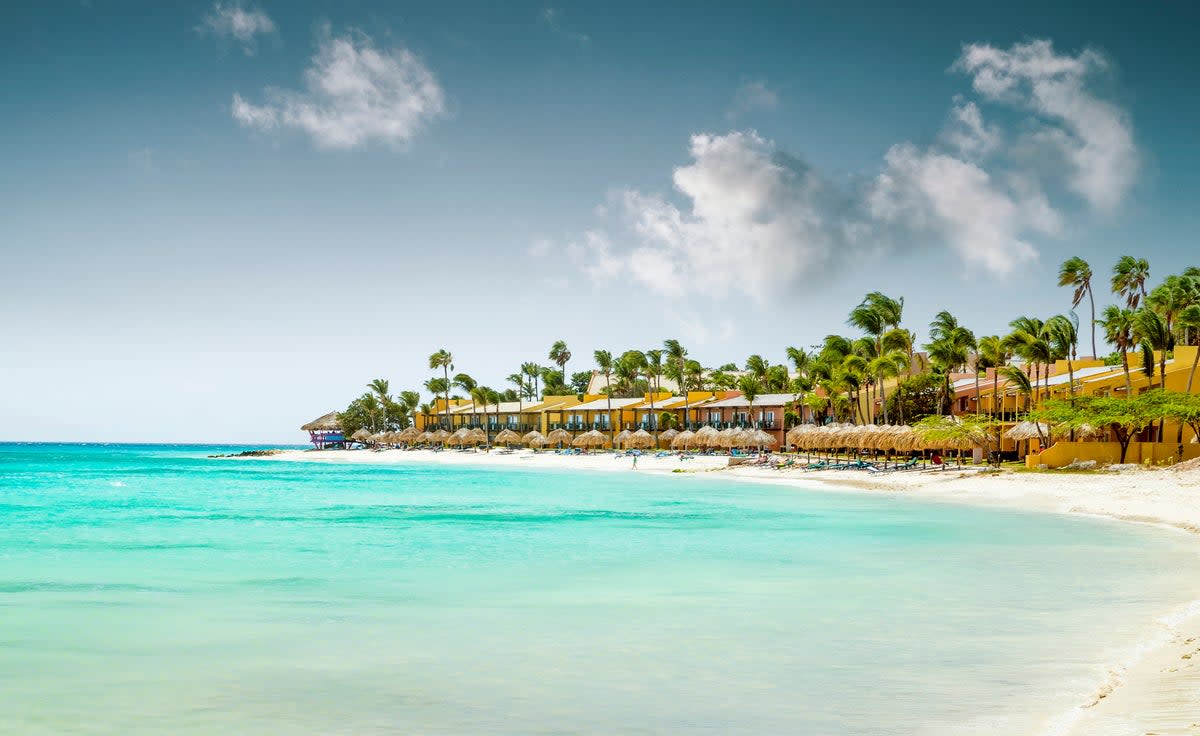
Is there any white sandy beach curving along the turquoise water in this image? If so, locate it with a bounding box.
[253,450,1200,736]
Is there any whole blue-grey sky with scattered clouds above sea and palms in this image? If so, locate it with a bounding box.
[0,0,1200,441]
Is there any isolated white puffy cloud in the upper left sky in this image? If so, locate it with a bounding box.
[233,31,446,149]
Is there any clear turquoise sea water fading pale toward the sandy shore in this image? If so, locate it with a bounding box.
[0,445,1200,735]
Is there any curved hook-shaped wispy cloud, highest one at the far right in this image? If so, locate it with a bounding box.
[955,40,1139,211]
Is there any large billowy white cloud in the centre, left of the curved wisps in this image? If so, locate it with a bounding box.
[570,131,851,300]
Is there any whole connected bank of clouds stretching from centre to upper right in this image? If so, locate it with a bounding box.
[556,41,1138,301]
